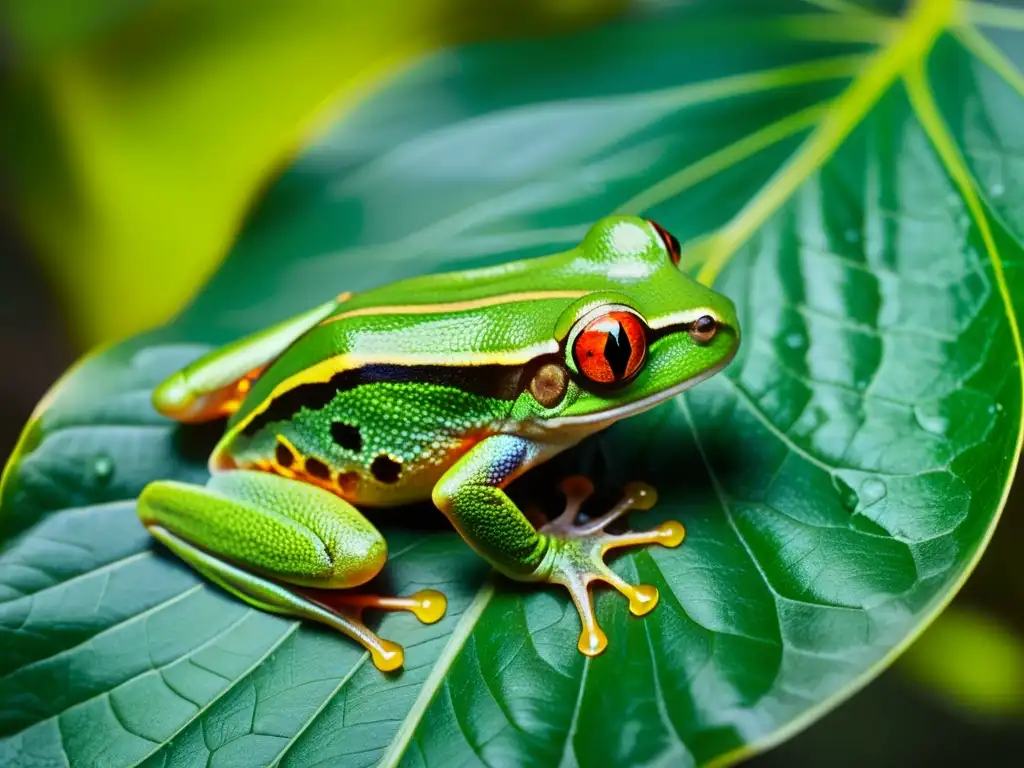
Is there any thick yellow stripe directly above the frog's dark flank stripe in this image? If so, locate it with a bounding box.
[232,342,559,432]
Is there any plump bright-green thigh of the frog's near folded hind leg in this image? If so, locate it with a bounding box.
[139,470,387,591]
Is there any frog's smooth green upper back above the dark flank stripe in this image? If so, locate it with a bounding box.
[229,255,585,434]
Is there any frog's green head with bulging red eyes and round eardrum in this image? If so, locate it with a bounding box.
[516,216,739,442]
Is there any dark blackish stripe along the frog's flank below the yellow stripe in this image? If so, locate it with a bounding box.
[241,355,544,436]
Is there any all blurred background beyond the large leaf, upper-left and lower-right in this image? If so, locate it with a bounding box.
[0,0,1024,766]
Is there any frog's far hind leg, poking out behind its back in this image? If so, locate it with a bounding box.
[153,297,342,422]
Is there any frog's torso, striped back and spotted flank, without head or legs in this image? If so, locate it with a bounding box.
[212,252,584,505]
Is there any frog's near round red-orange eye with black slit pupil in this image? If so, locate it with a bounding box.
[572,309,647,385]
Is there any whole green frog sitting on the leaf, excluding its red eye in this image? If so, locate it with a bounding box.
[139,216,739,669]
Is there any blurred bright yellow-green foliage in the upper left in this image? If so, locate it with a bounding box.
[0,0,623,348]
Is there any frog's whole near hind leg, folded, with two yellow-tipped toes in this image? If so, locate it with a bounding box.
[138,470,445,671]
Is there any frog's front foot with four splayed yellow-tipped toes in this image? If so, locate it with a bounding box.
[538,476,685,656]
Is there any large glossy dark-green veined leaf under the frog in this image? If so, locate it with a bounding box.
[0,0,1024,766]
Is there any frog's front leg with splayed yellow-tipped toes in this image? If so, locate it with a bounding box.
[433,435,684,656]
